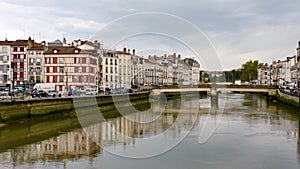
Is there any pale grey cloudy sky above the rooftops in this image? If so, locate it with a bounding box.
[0,0,300,70]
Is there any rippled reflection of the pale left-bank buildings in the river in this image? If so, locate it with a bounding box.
[0,102,197,163]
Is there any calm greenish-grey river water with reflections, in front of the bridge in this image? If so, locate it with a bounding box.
[0,94,300,169]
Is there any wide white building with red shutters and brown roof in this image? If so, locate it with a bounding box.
[44,46,98,92]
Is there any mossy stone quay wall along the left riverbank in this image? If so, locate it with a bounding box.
[0,92,150,127]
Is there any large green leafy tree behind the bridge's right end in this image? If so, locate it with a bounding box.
[241,60,258,82]
